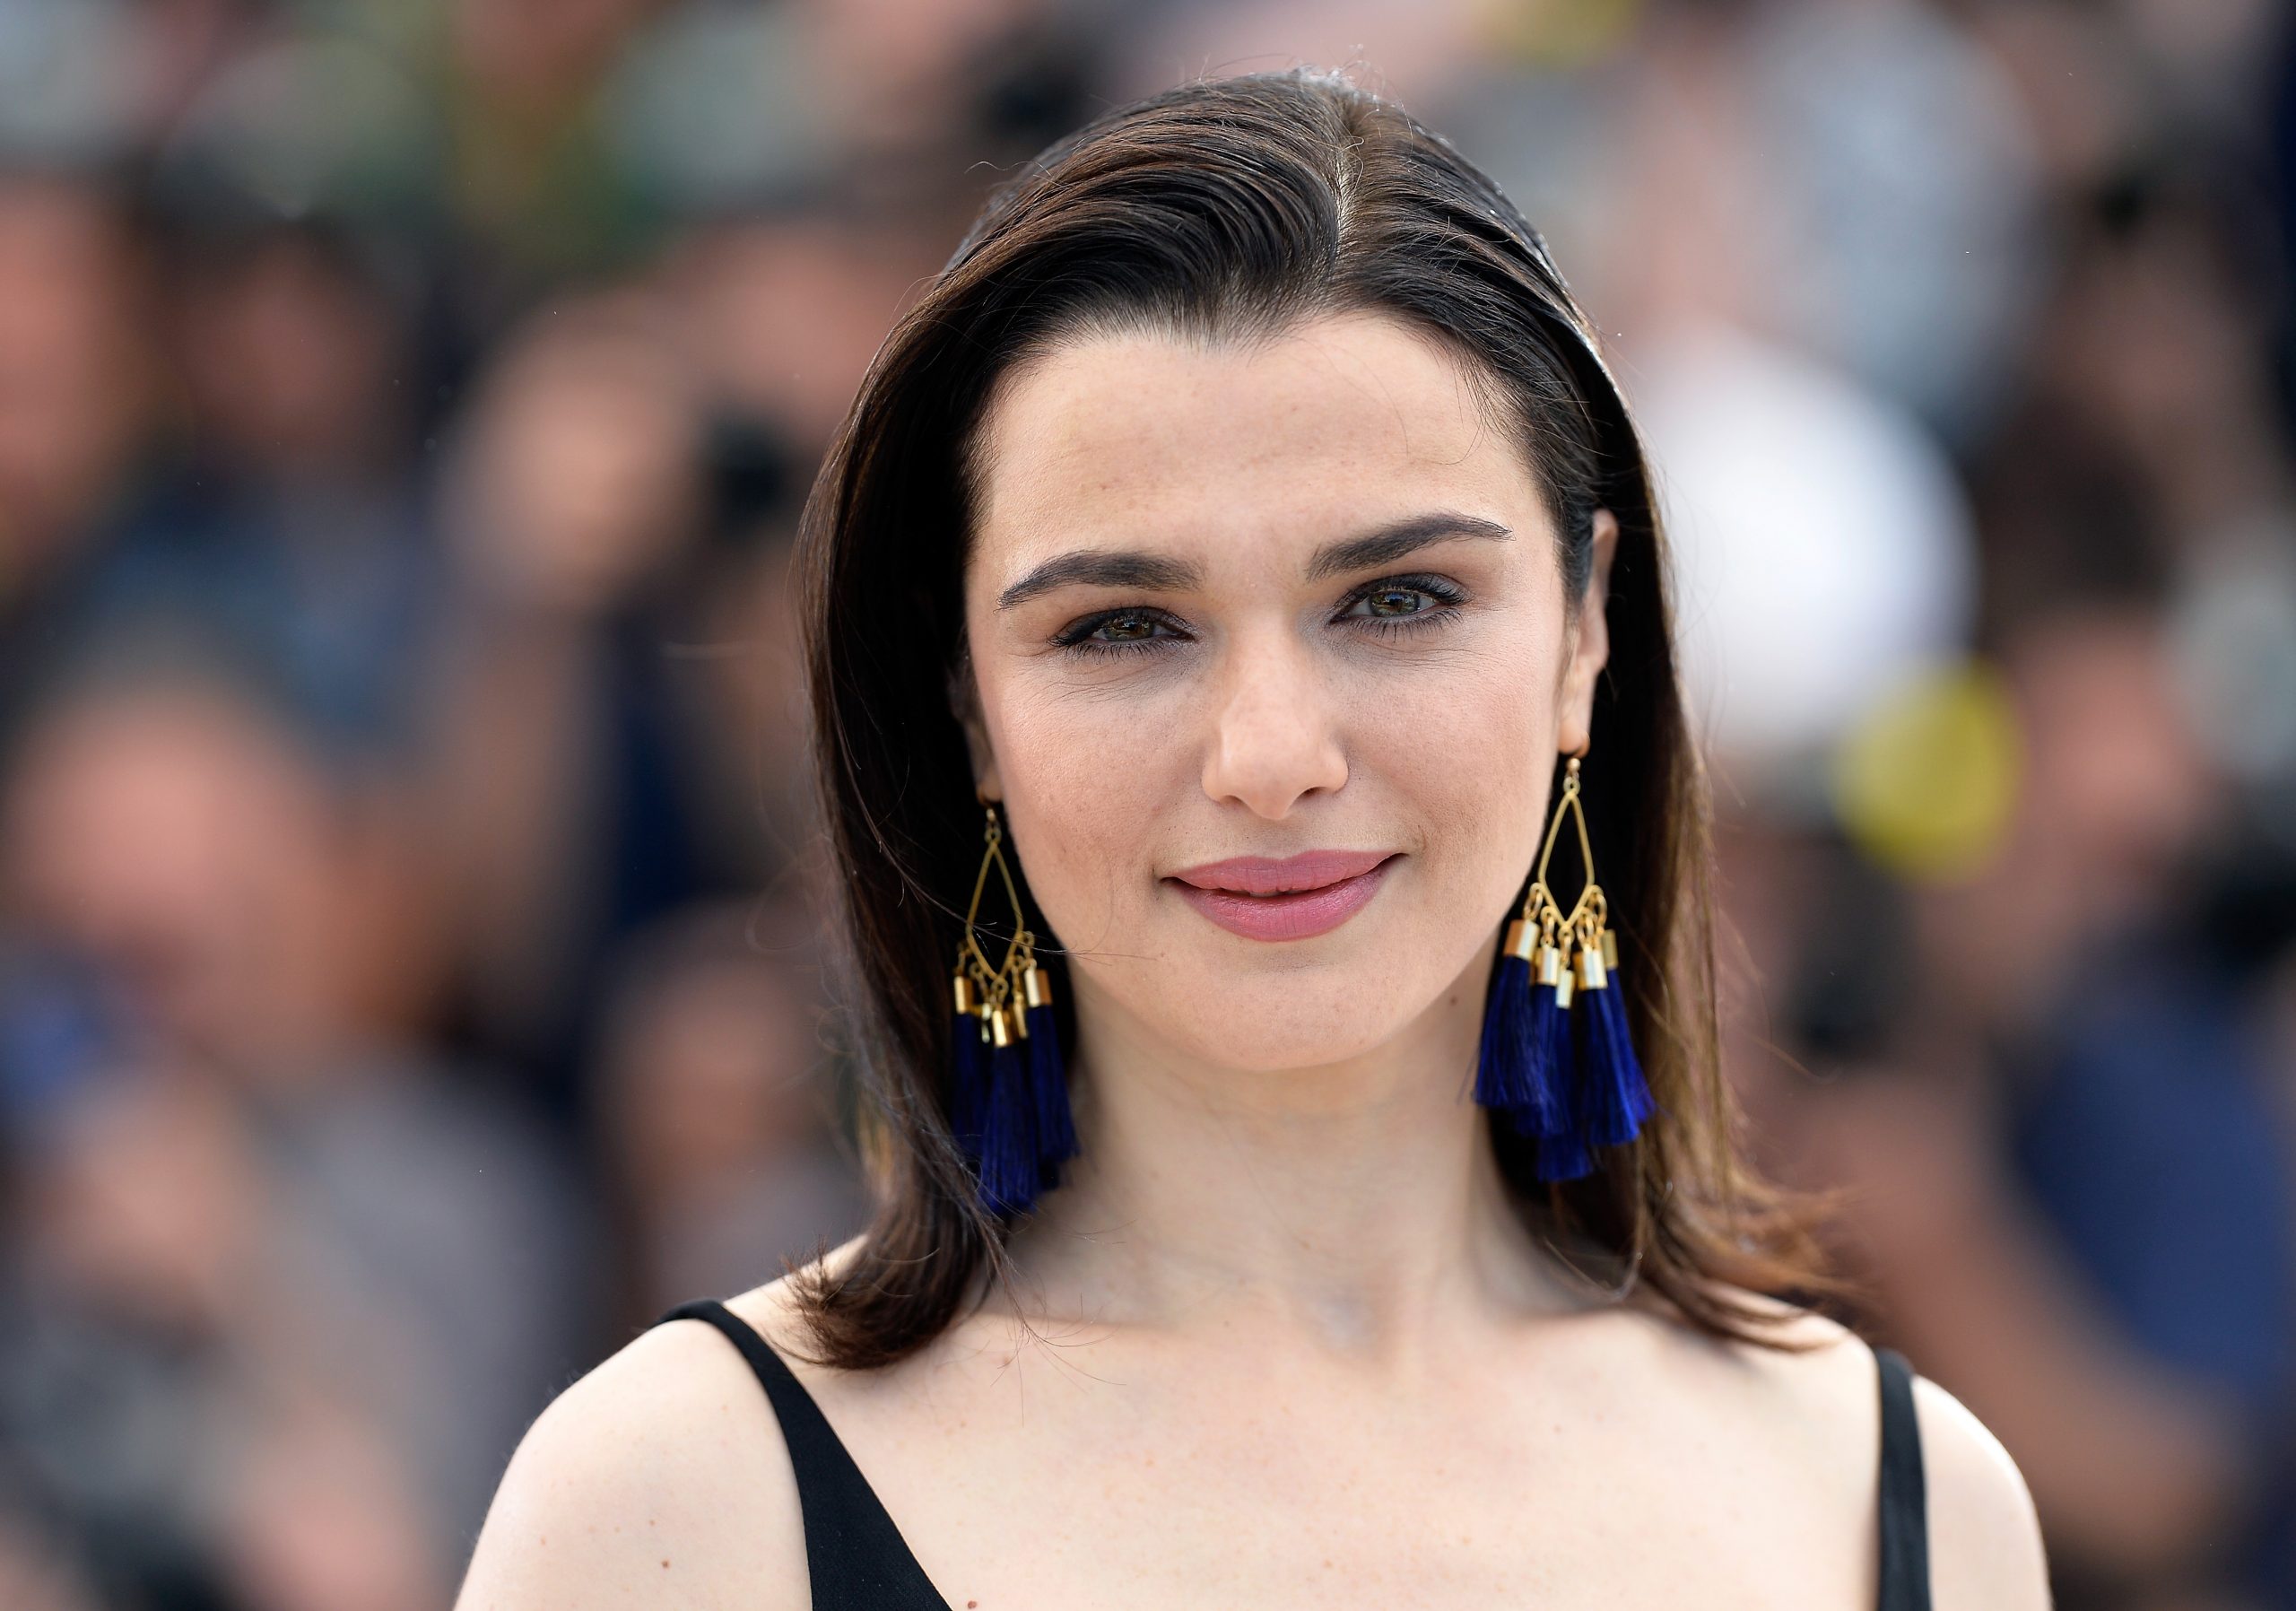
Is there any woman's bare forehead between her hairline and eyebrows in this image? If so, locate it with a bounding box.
[978,312,1536,562]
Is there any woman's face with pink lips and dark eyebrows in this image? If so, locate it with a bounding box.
[960,312,1616,1069]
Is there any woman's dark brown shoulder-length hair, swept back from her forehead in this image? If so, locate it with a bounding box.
[792,69,1841,1368]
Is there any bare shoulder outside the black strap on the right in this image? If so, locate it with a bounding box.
[1912,1374,2050,1611]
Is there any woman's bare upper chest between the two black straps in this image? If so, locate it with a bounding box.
[771,1338,1876,1611]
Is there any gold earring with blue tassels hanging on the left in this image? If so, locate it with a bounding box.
[948,801,1077,1214]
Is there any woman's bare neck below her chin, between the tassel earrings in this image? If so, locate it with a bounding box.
[1013,953,1591,1356]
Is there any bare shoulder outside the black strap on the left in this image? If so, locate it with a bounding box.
[455,1244,872,1611]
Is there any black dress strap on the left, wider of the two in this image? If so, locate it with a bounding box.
[655,1299,948,1611]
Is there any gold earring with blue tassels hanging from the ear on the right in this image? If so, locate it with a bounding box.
[1474,755,1657,1180]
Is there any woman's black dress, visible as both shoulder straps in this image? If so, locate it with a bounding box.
[655,1299,1931,1611]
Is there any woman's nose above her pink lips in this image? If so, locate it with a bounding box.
[1203,631,1348,822]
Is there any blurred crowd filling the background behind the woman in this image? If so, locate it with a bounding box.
[0,0,2296,1611]
